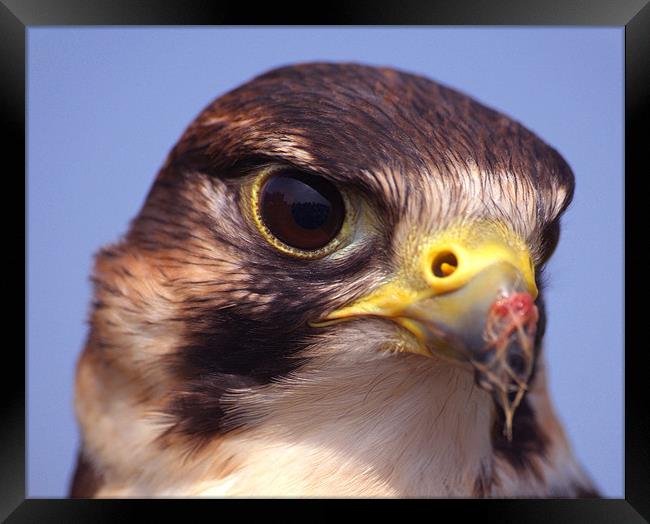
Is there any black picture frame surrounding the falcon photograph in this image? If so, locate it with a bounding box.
[6,0,650,524]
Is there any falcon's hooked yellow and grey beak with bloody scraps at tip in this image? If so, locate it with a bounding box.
[312,222,538,438]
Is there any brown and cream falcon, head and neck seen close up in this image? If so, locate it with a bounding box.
[70,63,597,497]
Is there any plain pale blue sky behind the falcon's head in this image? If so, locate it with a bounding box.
[27,27,624,497]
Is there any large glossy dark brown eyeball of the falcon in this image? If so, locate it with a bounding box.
[260,171,345,250]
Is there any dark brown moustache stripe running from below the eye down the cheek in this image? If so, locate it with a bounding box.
[161,246,377,449]
